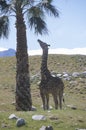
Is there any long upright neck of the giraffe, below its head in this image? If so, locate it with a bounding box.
[41,49,51,80]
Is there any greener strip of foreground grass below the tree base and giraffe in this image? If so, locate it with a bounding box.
[0,108,86,130]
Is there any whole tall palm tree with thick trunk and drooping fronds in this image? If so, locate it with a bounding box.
[0,0,59,111]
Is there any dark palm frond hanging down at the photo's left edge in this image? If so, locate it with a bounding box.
[0,16,9,38]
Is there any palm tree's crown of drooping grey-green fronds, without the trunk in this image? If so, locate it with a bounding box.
[0,0,59,37]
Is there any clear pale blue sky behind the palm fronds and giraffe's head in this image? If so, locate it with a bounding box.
[0,0,86,50]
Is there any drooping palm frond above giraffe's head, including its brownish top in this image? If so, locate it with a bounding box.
[27,6,48,35]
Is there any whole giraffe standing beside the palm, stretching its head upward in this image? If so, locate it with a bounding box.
[38,39,64,110]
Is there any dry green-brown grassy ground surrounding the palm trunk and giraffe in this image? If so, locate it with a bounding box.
[0,55,86,130]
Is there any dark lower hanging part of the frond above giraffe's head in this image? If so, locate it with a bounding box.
[29,17,48,35]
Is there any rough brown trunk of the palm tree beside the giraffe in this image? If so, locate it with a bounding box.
[16,3,32,111]
